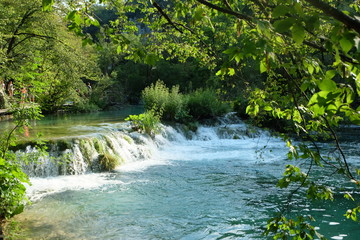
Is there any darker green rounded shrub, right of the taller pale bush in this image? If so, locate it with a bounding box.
[187,89,231,120]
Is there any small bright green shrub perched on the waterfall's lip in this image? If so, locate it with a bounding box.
[125,109,162,136]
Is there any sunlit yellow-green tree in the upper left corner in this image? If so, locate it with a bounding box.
[0,0,99,112]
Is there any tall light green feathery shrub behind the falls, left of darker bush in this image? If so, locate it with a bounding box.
[142,80,187,121]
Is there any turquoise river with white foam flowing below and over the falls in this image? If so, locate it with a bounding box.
[3,109,360,240]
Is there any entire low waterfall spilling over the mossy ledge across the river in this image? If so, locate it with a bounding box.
[17,115,259,177]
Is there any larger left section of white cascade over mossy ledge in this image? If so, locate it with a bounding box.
[17,124,169,177]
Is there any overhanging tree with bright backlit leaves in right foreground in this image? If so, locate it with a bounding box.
[44,0,360,239]
